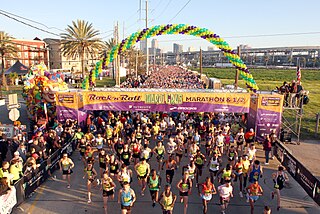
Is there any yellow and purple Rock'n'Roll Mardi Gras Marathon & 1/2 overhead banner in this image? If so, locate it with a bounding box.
[79,91,250,113]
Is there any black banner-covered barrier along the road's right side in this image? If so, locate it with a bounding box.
[275,142,320,205]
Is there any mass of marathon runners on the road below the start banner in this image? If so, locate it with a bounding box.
[54,111,288,214]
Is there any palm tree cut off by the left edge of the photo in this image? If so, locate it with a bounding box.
[0,31,18,86]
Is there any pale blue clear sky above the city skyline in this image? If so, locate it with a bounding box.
[0,0,320,50]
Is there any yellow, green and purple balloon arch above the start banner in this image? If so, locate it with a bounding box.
[82,24,259,92]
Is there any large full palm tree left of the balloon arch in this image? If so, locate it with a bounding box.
[61,20,104,78]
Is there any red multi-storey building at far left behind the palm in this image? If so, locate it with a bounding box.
[5,37,48,69]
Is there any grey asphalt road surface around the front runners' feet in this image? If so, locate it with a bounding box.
[13,142,320,214]
